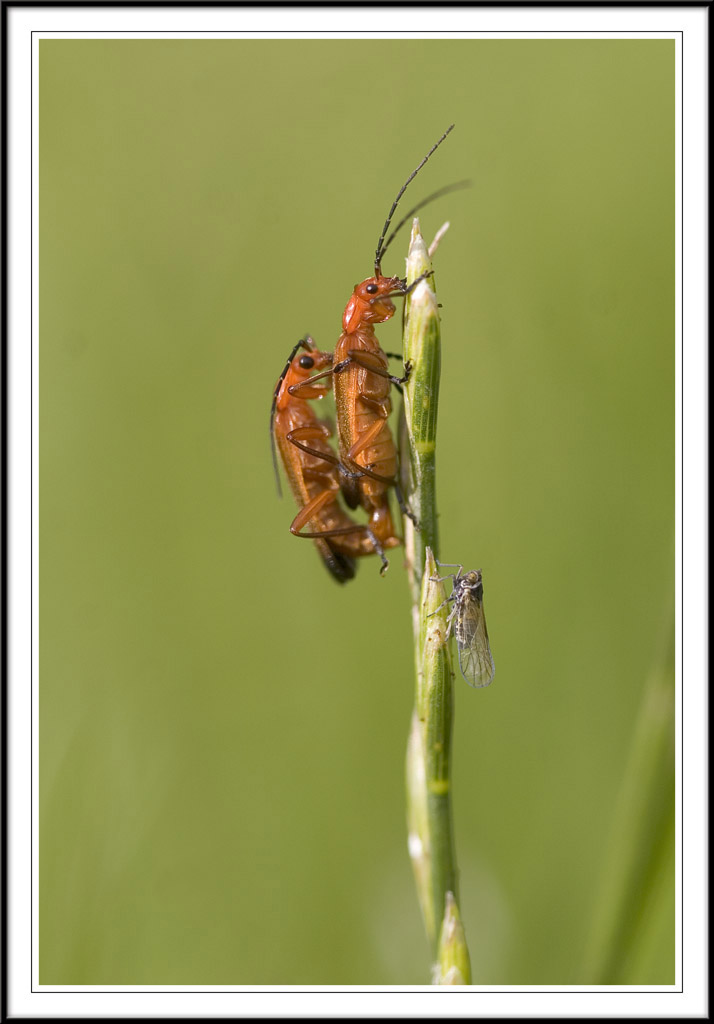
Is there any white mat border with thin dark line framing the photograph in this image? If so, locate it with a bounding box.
[6,6,708,1018]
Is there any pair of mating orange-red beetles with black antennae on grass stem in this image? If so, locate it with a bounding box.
[270,125,454,583]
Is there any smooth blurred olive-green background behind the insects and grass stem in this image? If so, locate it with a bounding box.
[40,39,674,985]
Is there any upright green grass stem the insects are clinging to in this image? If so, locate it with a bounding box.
[401,220,470,984]
